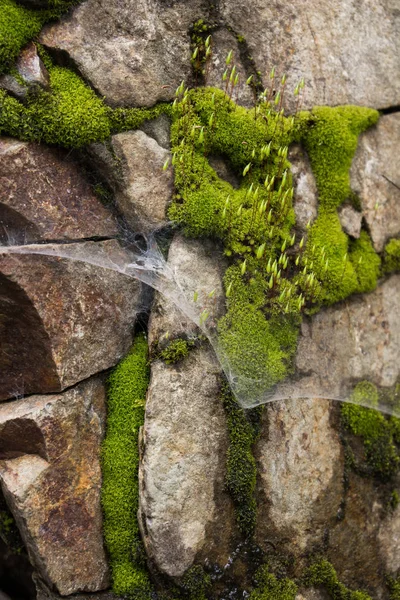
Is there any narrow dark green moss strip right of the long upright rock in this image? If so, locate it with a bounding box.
[221,383,262,537]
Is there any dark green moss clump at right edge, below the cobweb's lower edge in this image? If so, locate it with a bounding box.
[341,381,400,480]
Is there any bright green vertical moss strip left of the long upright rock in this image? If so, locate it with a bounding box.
[102,335,150,598]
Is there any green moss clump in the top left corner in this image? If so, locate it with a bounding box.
[0,0,79,73]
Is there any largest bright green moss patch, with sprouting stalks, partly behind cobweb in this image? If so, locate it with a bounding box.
[169,81,380,400]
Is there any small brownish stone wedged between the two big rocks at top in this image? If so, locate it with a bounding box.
[206,28,254,108]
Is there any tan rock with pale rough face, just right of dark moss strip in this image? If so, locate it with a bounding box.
[255,399,344,556]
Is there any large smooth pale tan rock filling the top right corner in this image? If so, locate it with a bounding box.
[219,0,400,111]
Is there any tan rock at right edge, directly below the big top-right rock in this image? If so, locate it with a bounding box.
[350,113,400,252]
